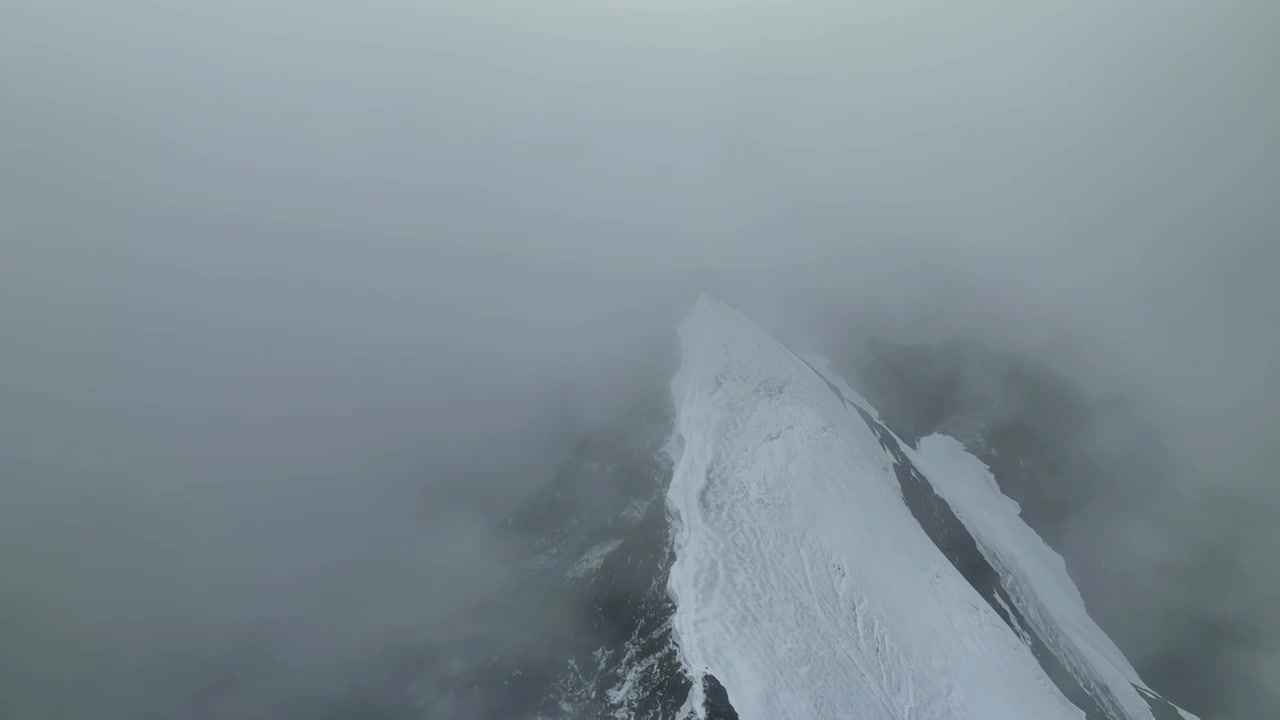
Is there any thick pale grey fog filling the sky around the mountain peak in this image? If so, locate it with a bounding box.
[0,0,1280,719]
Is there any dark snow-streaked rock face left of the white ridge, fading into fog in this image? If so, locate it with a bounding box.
[422,398,692,720]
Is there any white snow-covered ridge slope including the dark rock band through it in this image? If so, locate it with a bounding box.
[667,299,1192,720]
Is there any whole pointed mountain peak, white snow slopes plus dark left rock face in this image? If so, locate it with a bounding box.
[419,297,1192,720]
